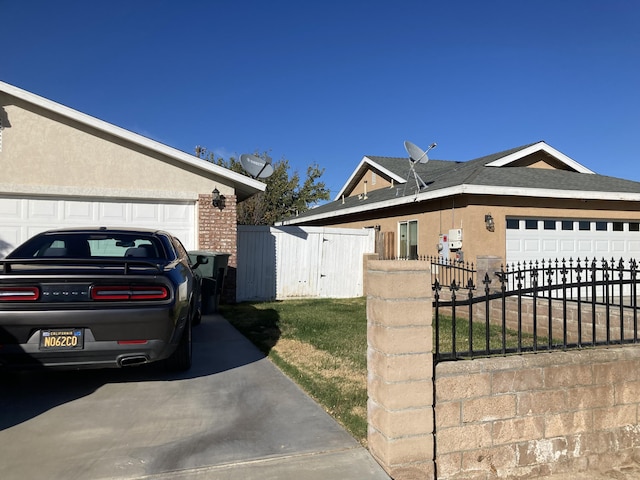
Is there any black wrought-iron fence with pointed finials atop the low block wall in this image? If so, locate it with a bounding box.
[432,255,638,361]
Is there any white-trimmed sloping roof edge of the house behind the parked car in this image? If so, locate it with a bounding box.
[0,81,266,202]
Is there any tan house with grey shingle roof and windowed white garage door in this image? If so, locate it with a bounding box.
[281,141,640,263]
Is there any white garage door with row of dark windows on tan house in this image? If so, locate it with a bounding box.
[506,218,640,263]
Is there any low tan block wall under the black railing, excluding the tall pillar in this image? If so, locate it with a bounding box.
[435,347,640,480]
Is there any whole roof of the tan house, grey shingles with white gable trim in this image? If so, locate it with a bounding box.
[282,141,640,225]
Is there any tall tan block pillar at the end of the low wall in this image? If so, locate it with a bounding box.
[366,260,435,480]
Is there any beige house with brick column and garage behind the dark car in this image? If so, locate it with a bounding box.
[0,82,265,284]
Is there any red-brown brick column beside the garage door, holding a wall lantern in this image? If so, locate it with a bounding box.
[198,194,238,302]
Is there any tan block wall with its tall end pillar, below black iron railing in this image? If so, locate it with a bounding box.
[365,258,640,480]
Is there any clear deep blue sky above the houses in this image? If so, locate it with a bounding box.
[0,0,640,196]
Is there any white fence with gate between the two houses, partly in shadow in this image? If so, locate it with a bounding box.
[236,225,375,302]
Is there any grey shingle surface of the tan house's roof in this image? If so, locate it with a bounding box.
[285,144,640,223]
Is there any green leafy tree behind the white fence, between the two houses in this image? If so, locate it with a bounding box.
[196,147,329,225]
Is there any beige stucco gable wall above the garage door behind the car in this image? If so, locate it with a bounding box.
[0,93,234,200]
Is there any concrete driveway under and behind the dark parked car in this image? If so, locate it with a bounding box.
[0,315,389,480]
